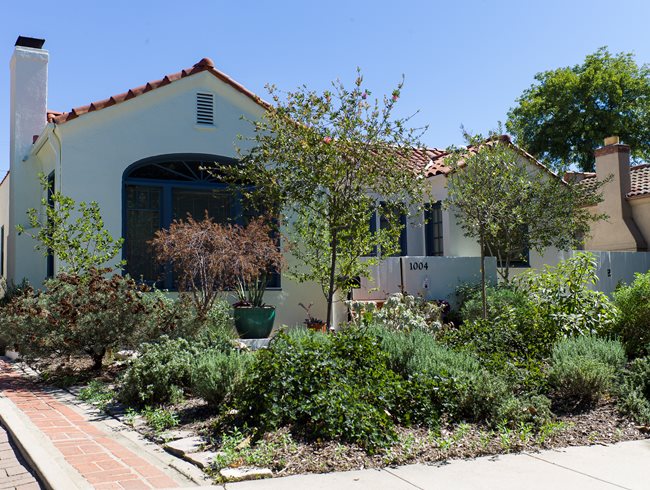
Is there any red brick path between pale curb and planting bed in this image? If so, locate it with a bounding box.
[0,359,179,490]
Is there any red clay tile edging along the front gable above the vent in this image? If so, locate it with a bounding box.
[47,58,269,124]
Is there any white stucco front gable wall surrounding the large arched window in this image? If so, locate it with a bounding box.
[8,72,345,325]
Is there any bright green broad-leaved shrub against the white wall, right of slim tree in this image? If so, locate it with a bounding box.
[516,253,618,339]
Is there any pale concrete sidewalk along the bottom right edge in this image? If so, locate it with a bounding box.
[225,440,650,490]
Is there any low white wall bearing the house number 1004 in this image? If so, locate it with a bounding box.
[352,257,497,304]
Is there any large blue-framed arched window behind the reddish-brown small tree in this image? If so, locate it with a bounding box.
[122,155,280,290]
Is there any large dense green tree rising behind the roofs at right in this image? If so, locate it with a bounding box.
[506,47,650,171]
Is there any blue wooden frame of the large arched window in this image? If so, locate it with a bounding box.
[122,153,282,291]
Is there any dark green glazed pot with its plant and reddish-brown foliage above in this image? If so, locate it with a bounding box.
[233,218,283,339]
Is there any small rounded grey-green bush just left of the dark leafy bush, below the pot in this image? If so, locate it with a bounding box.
[192,349,254,407]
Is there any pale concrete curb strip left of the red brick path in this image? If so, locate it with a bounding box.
[0,395,92,490]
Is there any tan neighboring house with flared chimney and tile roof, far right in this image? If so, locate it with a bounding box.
[564,137,650,252]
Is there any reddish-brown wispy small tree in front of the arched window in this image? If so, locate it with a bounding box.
[151,215,282,318]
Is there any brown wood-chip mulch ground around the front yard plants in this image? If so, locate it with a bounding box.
[20,359,650,476]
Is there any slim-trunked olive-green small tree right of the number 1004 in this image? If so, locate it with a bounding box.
[445,133,603,318]
